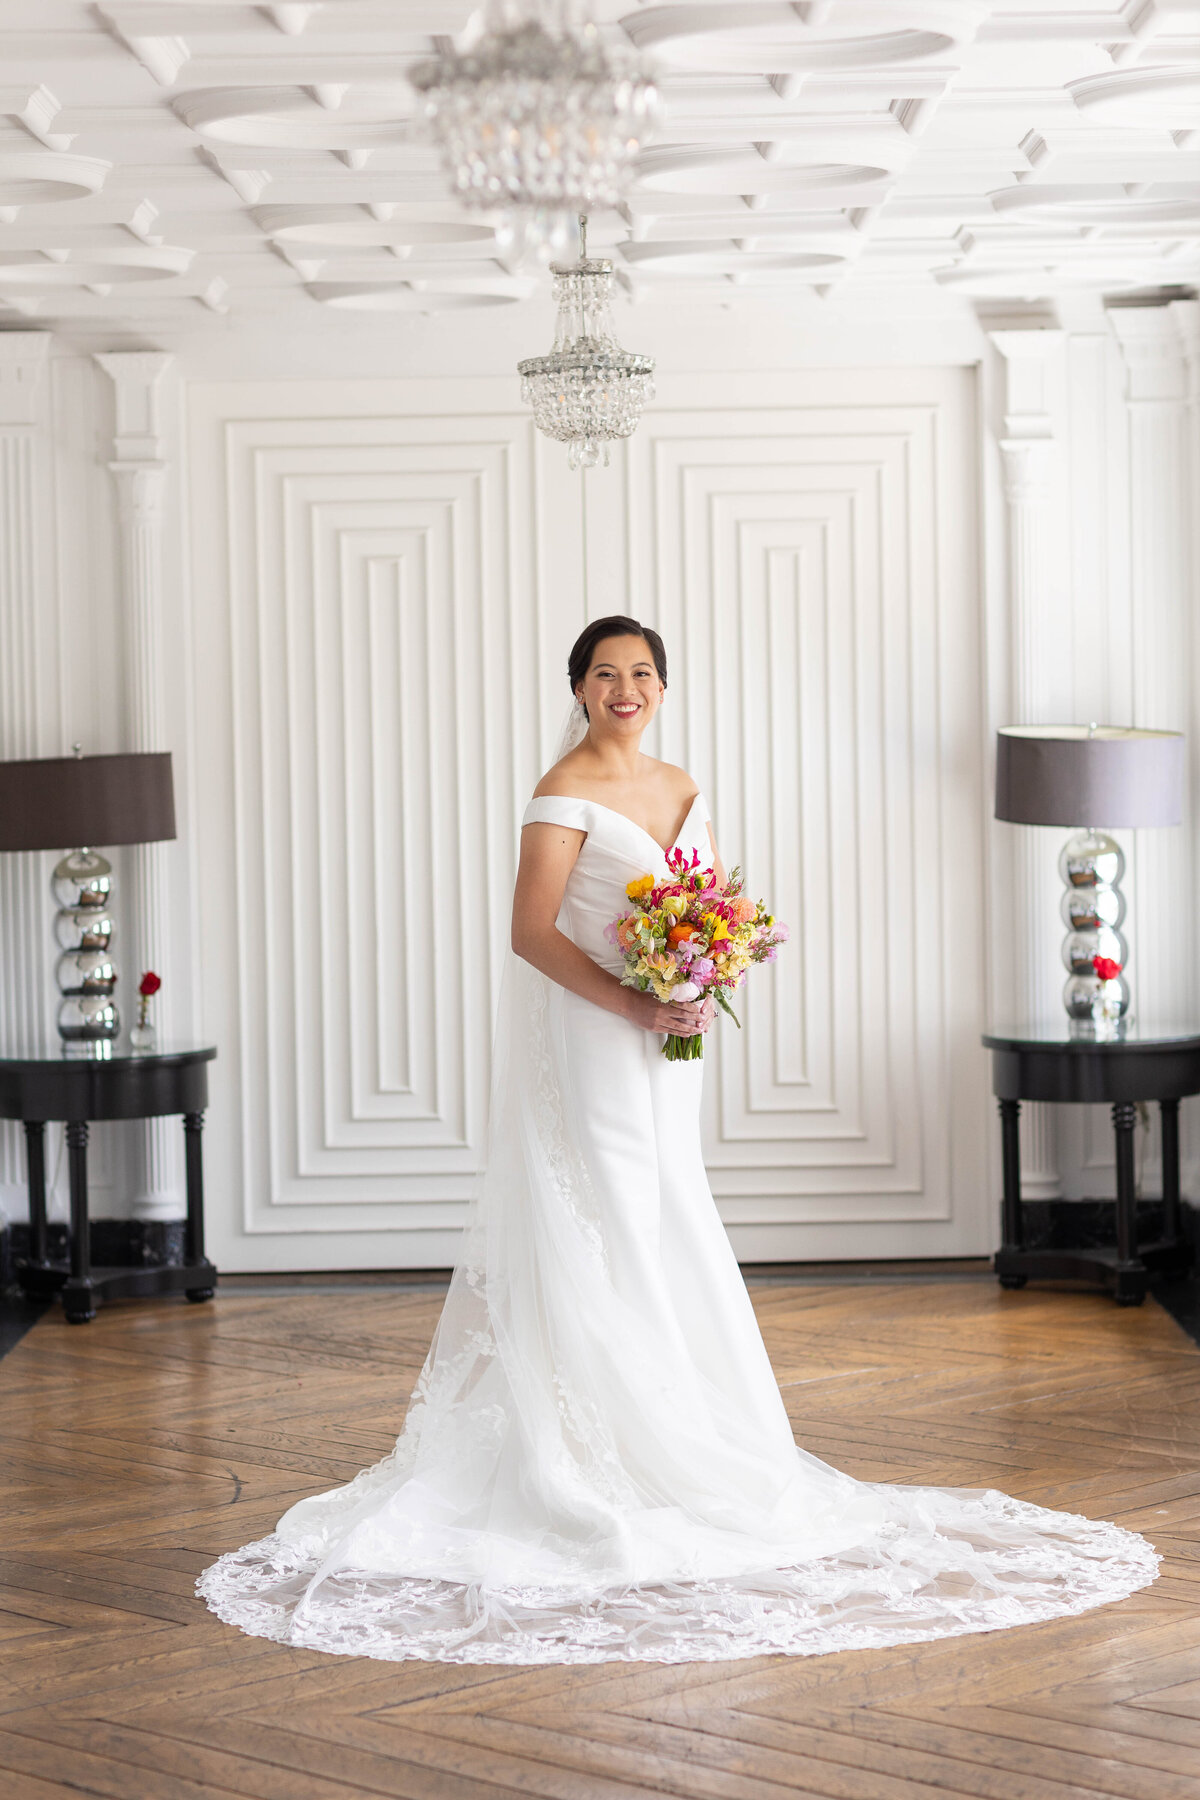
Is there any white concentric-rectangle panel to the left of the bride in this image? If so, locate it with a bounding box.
[191,396,536,1265]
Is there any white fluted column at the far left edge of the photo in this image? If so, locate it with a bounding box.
[0,331,59,1217]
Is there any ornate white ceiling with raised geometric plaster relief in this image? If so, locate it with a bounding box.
[0,0,1200,342]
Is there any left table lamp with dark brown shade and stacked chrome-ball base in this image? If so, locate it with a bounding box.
[0,752,175,1057]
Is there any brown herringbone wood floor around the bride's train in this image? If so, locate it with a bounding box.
[0,1282,1200,1800]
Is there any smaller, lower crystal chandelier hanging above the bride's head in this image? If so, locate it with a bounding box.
[516,218,655,468]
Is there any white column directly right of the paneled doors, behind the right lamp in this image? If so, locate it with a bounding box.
[991,331,1065,1199]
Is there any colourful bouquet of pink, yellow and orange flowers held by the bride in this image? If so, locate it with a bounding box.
[604,850,788,1062]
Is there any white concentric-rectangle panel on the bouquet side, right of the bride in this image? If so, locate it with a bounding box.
[592,371,990,1258]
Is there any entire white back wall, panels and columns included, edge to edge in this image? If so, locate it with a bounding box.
[0,316,1200,1271]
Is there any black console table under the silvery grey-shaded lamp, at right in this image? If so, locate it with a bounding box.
[984,1017,1200,1307]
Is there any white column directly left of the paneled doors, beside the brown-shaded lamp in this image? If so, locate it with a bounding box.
[95,351,184,1219]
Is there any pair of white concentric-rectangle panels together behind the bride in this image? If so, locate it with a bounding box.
[189,369,990,1267]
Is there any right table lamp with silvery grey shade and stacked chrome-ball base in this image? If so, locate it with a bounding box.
[995,725,1184,1035]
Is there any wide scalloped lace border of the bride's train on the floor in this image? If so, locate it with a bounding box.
[198,1489,1159,1665]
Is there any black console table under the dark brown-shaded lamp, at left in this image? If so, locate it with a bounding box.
[0,1046,218,1325]
